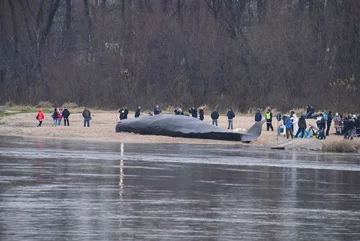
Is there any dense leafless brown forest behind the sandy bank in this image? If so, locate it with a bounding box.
[0,0,360,111]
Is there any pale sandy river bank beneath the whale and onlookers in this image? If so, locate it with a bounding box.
[0,111,354,147]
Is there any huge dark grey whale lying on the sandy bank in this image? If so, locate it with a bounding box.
[115,114,265,143]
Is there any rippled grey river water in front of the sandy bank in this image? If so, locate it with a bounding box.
[0,137,360,240]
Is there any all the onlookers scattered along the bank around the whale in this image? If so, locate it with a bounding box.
[36,105,360,140]
